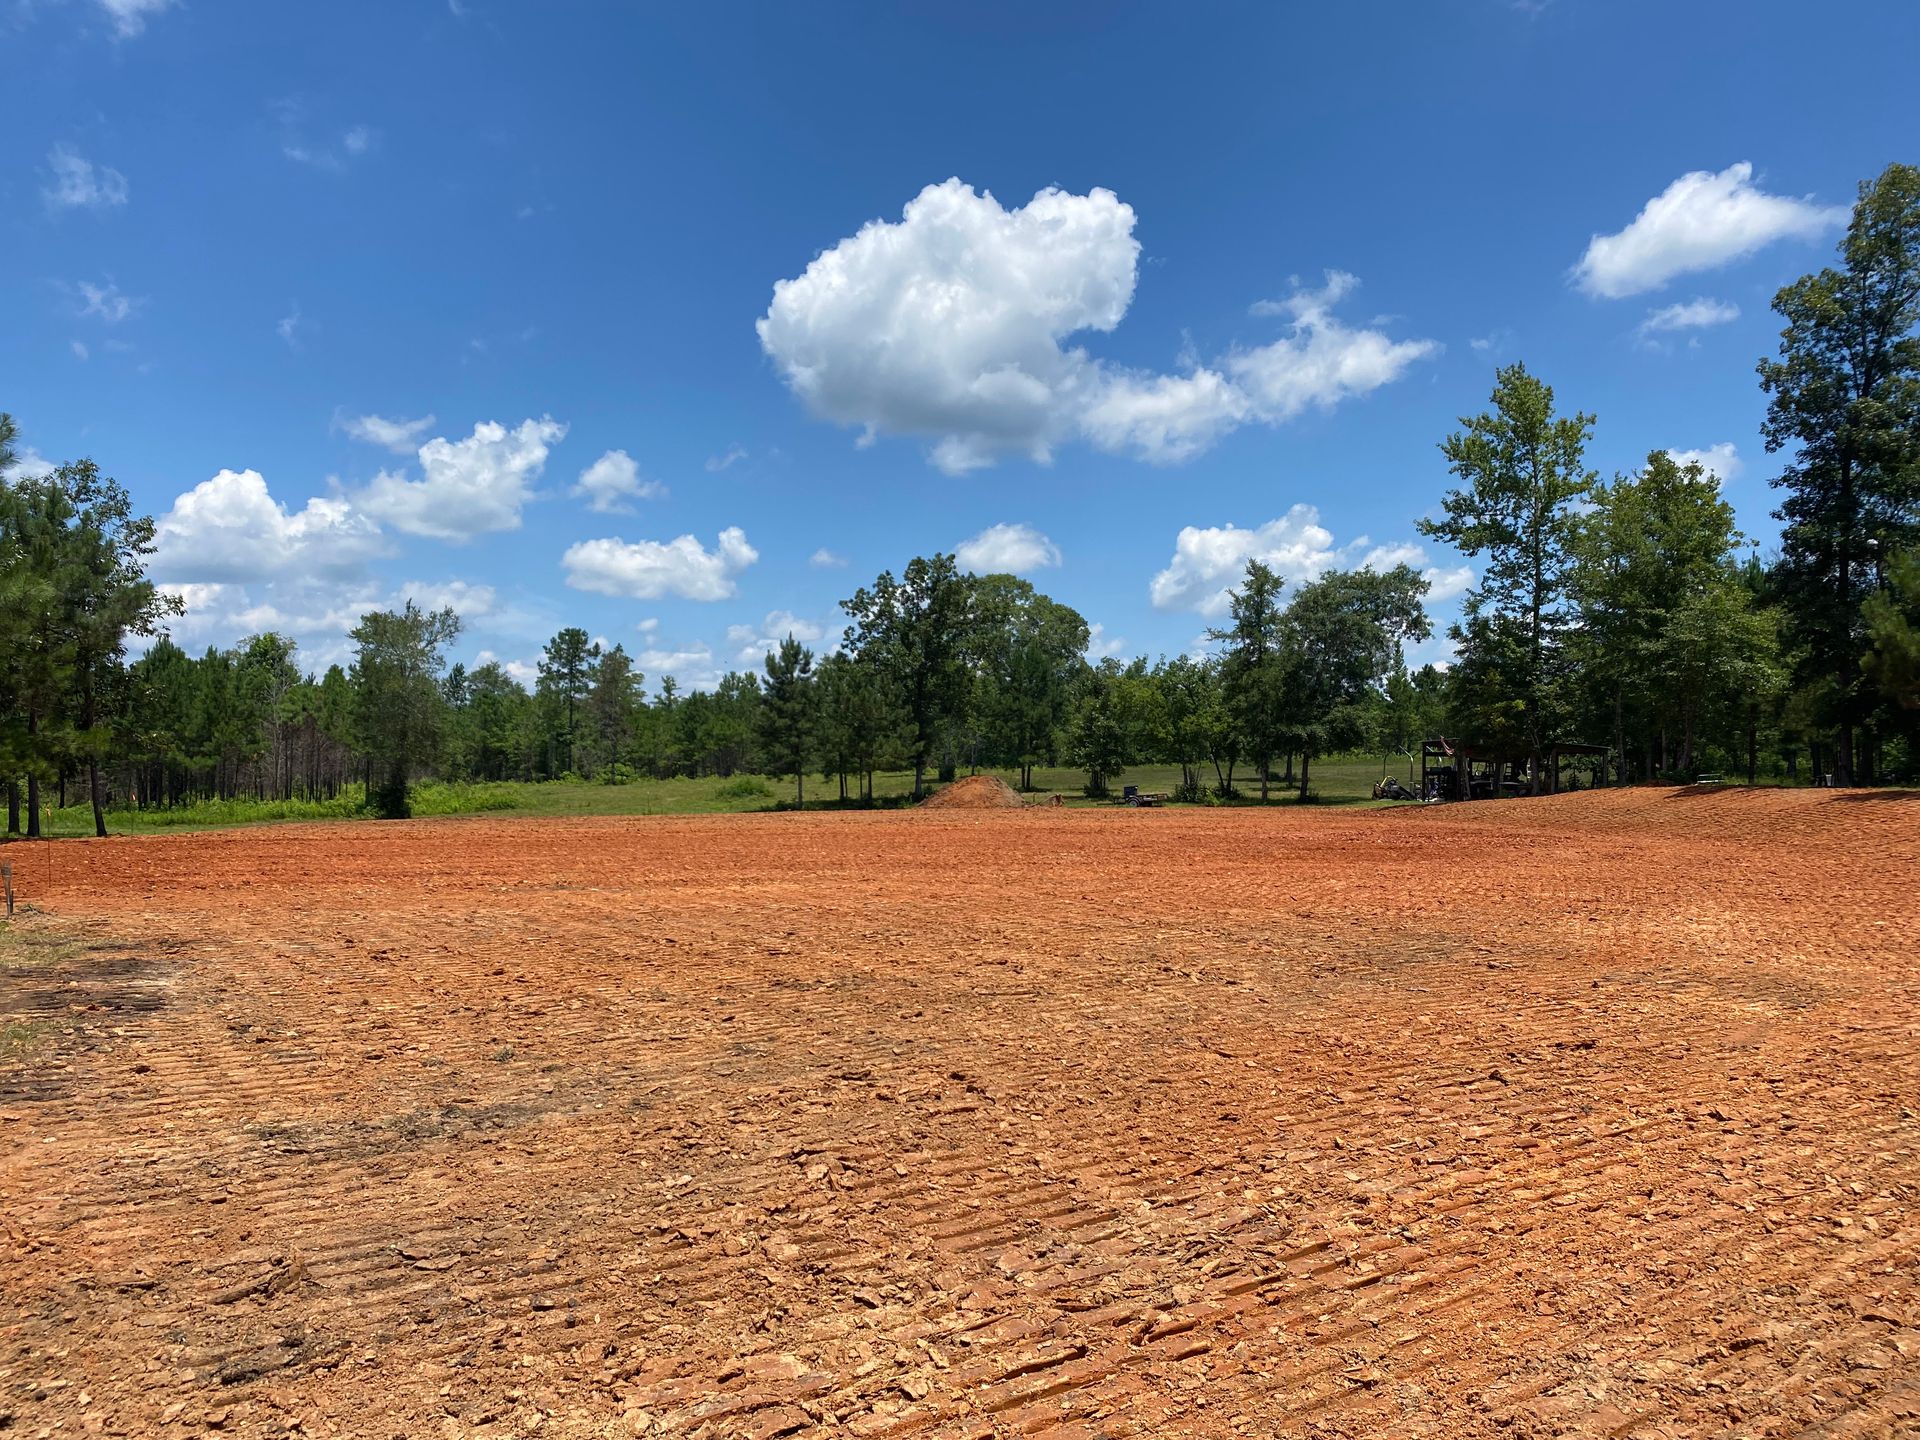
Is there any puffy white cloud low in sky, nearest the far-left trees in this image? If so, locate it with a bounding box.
[148,470,386,586]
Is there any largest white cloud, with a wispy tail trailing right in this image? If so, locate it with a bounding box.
[756,179,1438,474]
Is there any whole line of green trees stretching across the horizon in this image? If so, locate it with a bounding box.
[0,165,1920,833]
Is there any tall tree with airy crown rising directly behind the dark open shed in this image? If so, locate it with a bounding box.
[1419,365,1596,795]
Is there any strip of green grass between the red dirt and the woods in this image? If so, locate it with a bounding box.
[15,756,1407,839]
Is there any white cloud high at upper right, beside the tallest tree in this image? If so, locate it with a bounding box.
[1572,161,1847,300]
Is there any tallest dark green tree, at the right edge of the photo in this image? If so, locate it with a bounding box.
[1759,165,1920,785]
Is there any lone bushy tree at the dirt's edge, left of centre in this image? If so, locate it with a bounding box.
[349,599,461,820]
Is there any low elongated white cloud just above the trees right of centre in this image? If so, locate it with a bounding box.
[1148,505,1473,616]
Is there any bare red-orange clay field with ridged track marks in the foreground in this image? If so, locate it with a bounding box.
[0,791,1920,1440]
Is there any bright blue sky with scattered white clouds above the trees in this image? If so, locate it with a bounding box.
[0,0,1920,684]
